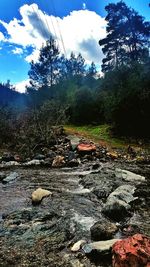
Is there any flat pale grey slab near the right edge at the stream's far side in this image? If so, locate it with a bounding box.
[116,171,145,182]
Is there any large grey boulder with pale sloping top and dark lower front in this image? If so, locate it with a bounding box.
[102,185,137,221]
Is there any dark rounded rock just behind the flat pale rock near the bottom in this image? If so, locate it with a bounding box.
[90,221,118,241]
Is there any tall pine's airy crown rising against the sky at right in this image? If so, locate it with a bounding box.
[99,1,150,72]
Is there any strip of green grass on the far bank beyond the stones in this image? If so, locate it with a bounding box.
[65,124,127,148]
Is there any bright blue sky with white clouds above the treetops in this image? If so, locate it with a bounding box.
[0,0,150,92]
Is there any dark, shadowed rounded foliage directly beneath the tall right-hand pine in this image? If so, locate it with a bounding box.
[101,63,150,137]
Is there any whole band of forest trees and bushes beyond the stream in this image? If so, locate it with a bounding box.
[0,1,150,151]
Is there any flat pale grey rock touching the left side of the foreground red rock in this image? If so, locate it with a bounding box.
[82,239,119,254]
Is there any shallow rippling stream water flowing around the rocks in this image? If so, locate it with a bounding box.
[0,162,150,267]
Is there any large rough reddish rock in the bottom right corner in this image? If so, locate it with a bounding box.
[112,234,150,267]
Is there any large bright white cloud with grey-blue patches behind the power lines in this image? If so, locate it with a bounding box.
[0,3,106,64]
